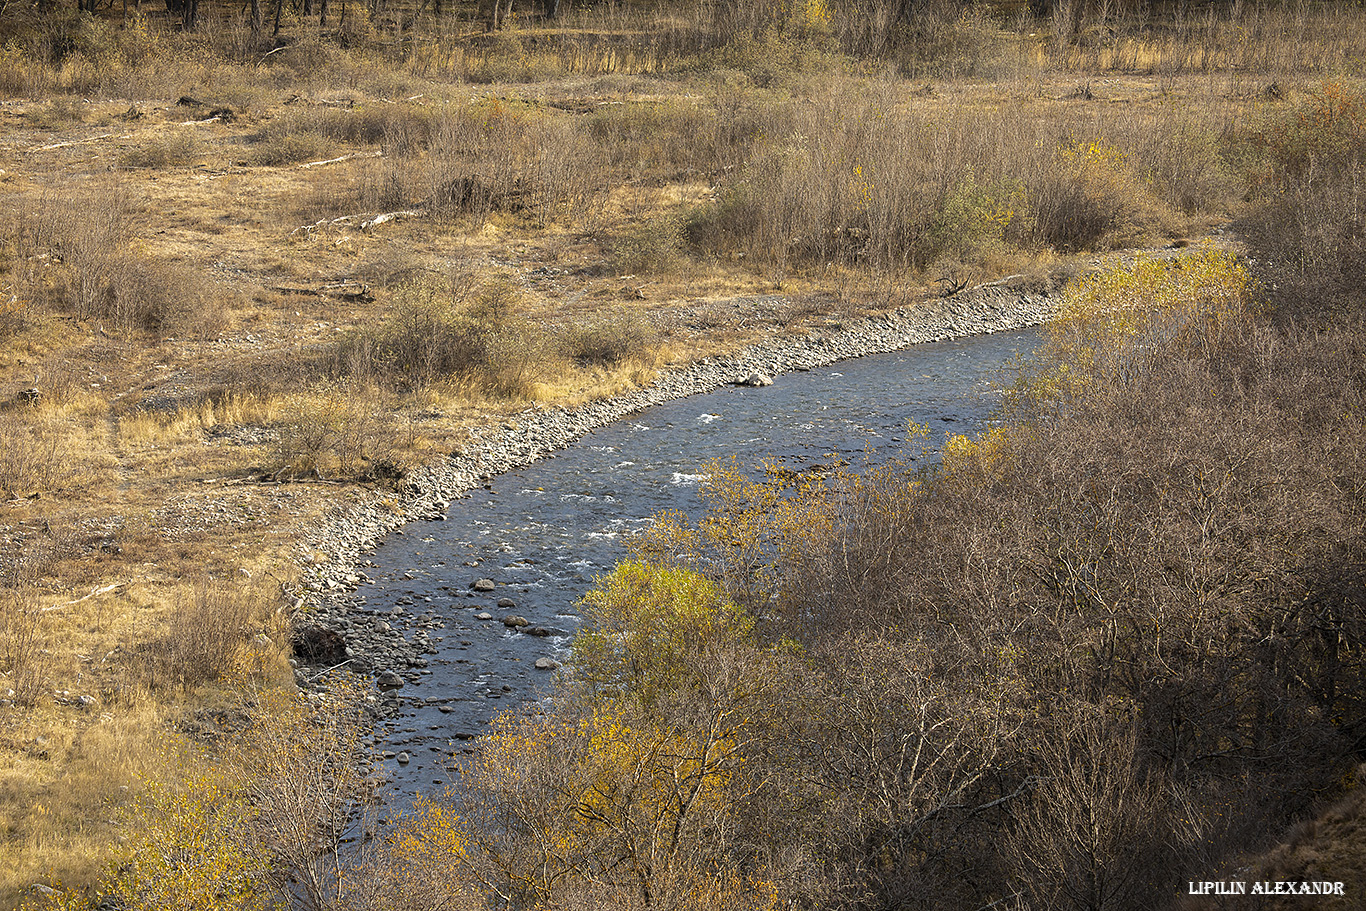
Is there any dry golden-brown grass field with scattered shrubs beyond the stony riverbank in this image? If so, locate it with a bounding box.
[0,0,1366,908]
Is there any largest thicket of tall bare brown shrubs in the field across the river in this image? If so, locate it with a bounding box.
[686,85,1190,273]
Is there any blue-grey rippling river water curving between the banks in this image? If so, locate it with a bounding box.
[357,329,1038,806]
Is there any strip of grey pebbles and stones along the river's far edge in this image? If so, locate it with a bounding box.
[285,279,1057,688]
